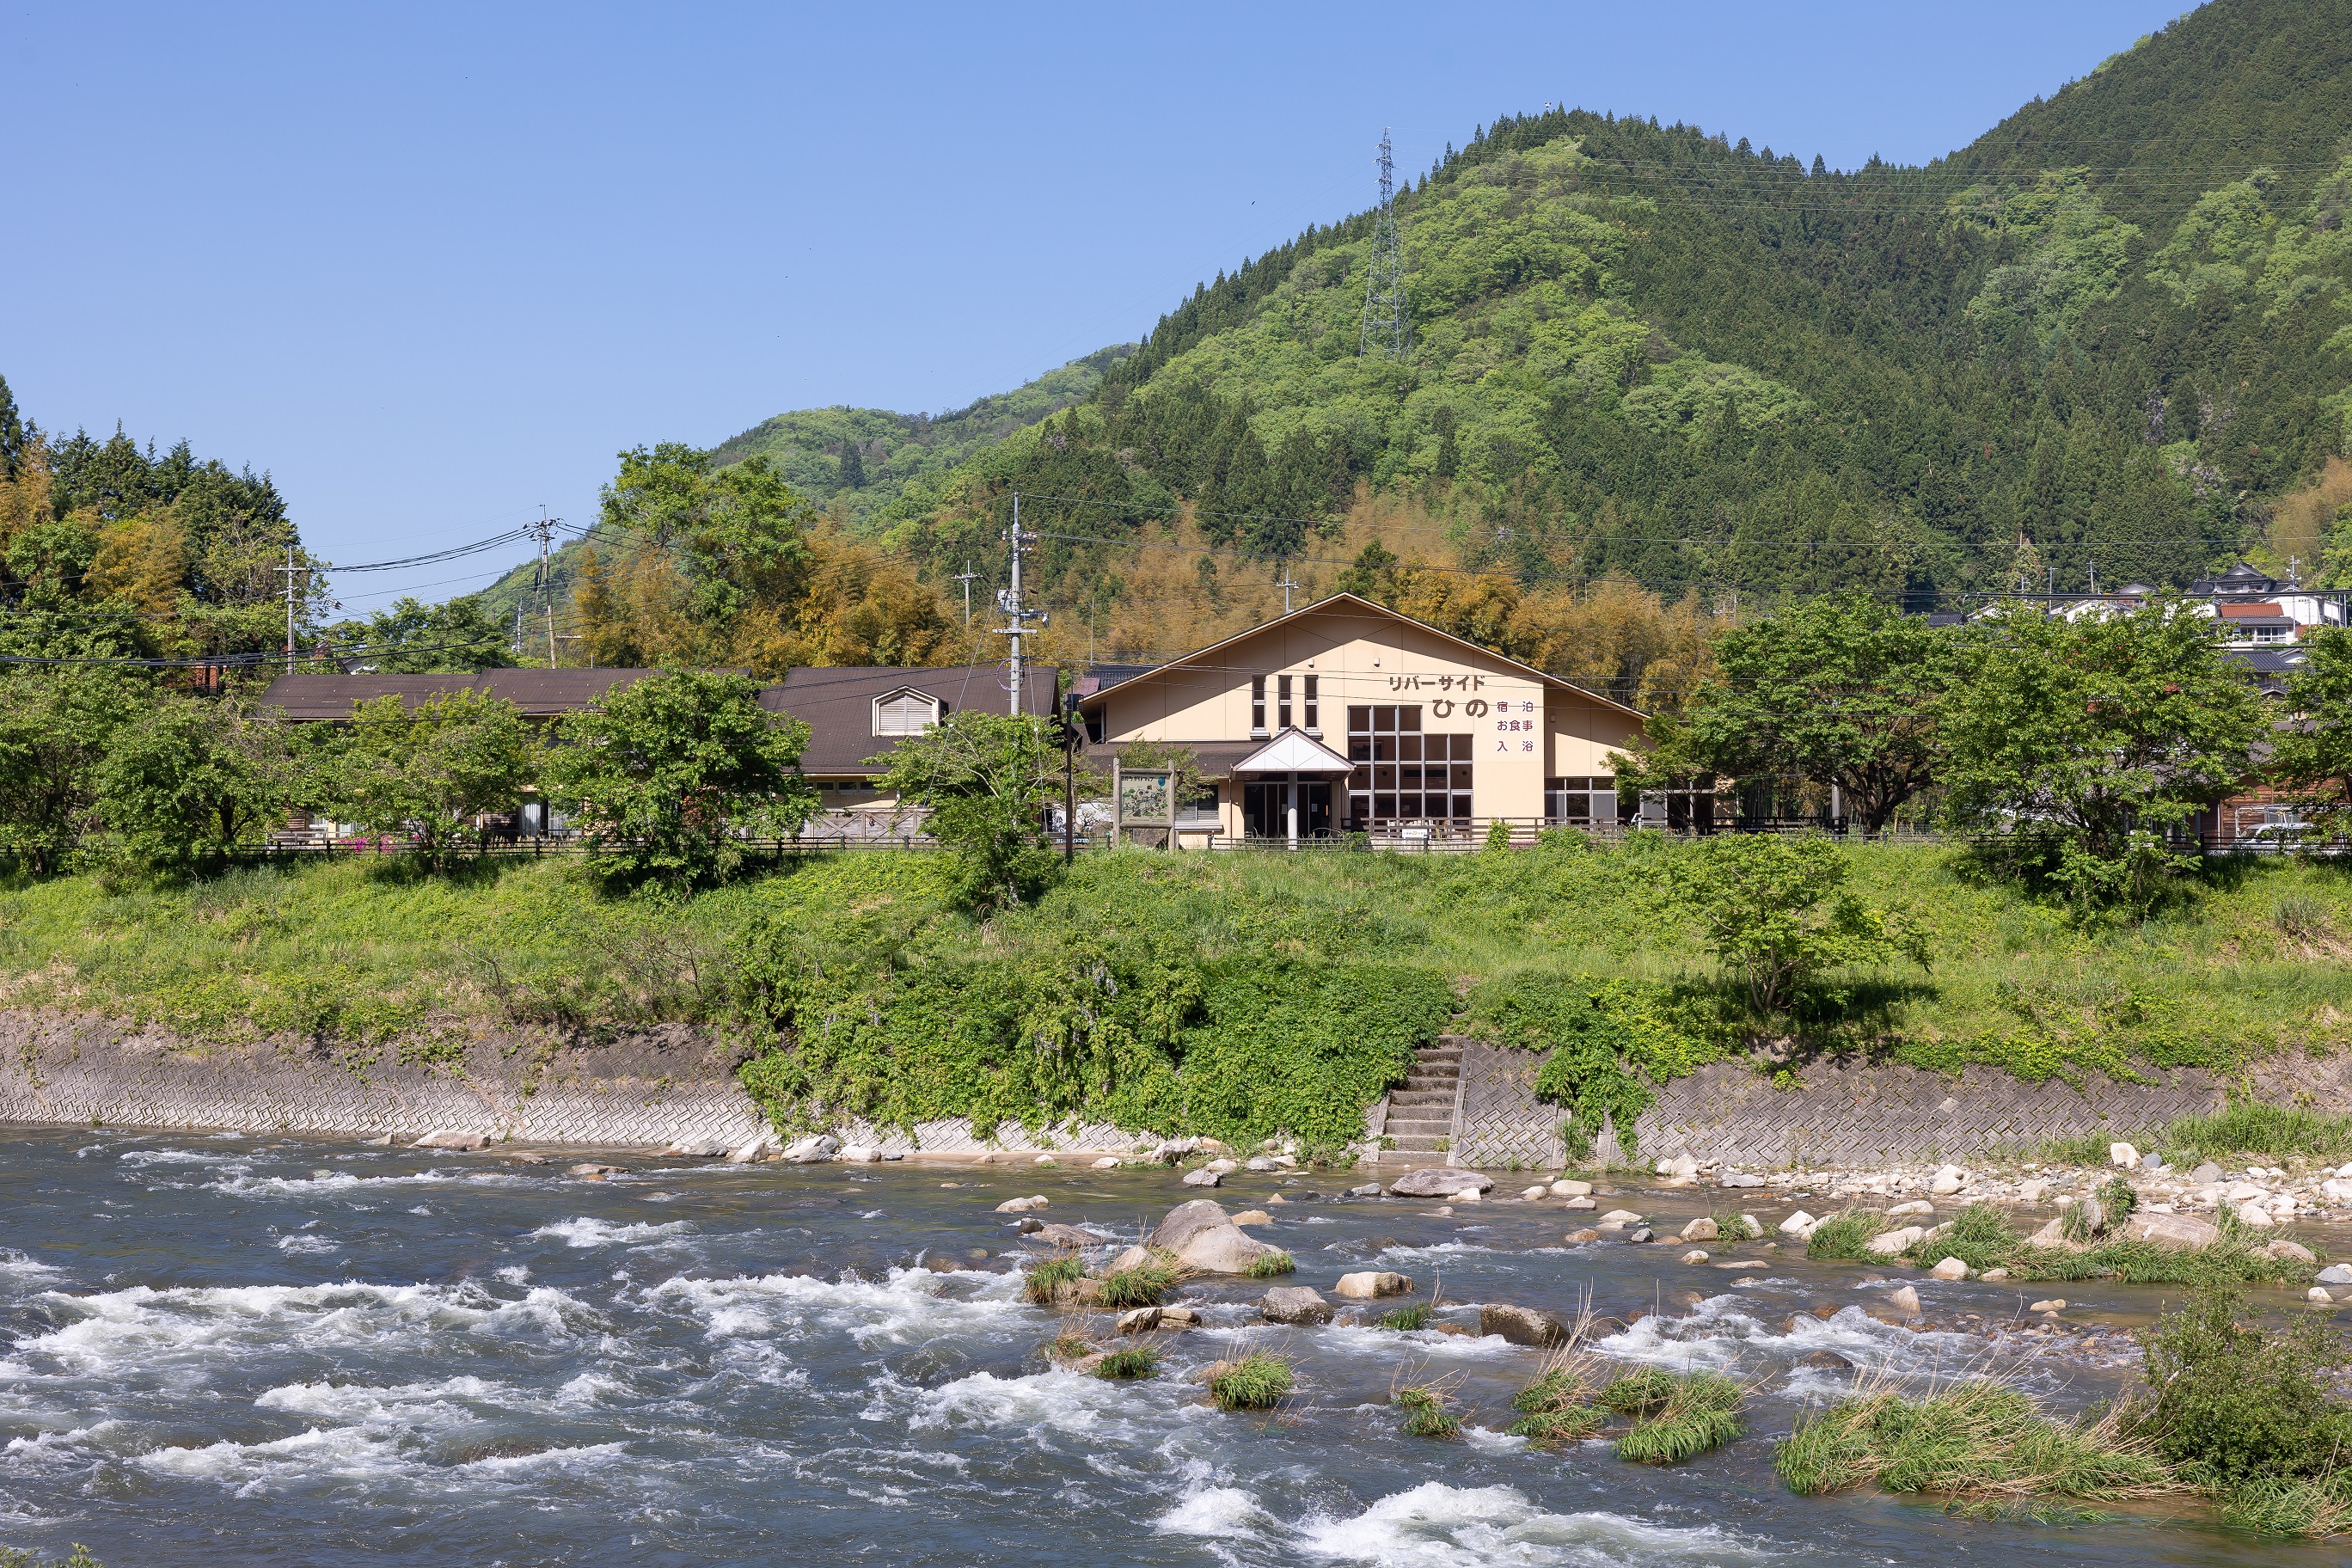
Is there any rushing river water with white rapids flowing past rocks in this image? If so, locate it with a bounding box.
[0,1133,2343,1568]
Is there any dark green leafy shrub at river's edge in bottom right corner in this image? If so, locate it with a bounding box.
[2141,1286,2352,1488]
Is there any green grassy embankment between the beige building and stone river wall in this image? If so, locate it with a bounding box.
[14,842,2352,1138]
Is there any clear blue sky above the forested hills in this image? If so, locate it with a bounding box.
[0,0,2183,609]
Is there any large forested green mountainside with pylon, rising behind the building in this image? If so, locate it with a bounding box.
[855,0,2352,625]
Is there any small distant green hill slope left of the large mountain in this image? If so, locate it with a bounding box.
[715,343,1134,524]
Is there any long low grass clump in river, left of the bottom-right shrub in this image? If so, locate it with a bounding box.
[1773,1382,2185,1504]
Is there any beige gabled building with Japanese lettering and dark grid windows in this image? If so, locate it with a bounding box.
[1075,592,1642,842]
